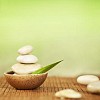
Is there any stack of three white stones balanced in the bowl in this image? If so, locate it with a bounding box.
[12,45,41,74]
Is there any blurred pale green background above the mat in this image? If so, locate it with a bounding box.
[0,0,100,76]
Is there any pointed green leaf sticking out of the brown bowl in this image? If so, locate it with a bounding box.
[32,60,63,74]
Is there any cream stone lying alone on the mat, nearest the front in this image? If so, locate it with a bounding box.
[55,89,82,98]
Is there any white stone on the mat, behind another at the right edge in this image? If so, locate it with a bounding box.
[77,75,99,85]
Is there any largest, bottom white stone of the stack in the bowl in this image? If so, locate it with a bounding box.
[11,63,41,74]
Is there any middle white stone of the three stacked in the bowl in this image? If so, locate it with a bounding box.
[16,55,38,64]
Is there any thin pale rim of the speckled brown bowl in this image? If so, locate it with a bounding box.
[4,71,48,76]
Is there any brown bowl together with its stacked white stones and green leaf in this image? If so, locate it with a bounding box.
[4,45,62,90]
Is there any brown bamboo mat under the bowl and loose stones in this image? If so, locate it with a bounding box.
[0,77,100,100]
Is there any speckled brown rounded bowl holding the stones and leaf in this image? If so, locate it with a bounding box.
[4,71,48,90]
